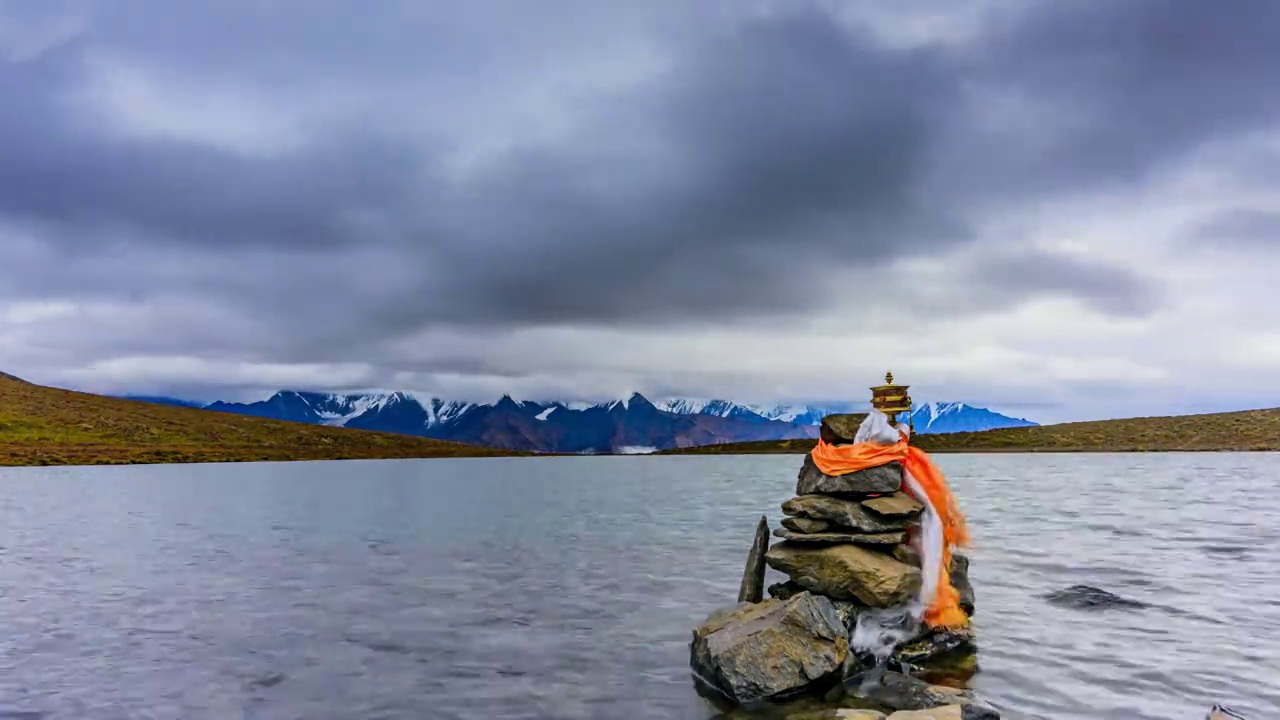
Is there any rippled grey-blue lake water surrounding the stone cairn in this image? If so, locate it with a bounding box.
[0,454,1280,720]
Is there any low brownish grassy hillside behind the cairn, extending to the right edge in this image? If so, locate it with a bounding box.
[664,409,1280,455]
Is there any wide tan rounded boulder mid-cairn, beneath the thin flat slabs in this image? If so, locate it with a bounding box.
[764,541,920,607]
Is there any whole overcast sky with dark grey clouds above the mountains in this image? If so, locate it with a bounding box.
[0,0,1280,421]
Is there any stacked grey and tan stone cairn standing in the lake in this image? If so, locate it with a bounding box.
[690,414,998,720]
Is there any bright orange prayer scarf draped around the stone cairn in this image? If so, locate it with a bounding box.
[813,430,969,628]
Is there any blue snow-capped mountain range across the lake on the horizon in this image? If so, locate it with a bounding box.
[137,391,1034,452]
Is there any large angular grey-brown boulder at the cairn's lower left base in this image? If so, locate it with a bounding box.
[690,592,849,703]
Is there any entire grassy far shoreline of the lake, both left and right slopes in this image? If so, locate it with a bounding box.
[0,375,1280,466]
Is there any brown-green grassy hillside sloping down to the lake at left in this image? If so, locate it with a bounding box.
[0,373,513,465]
